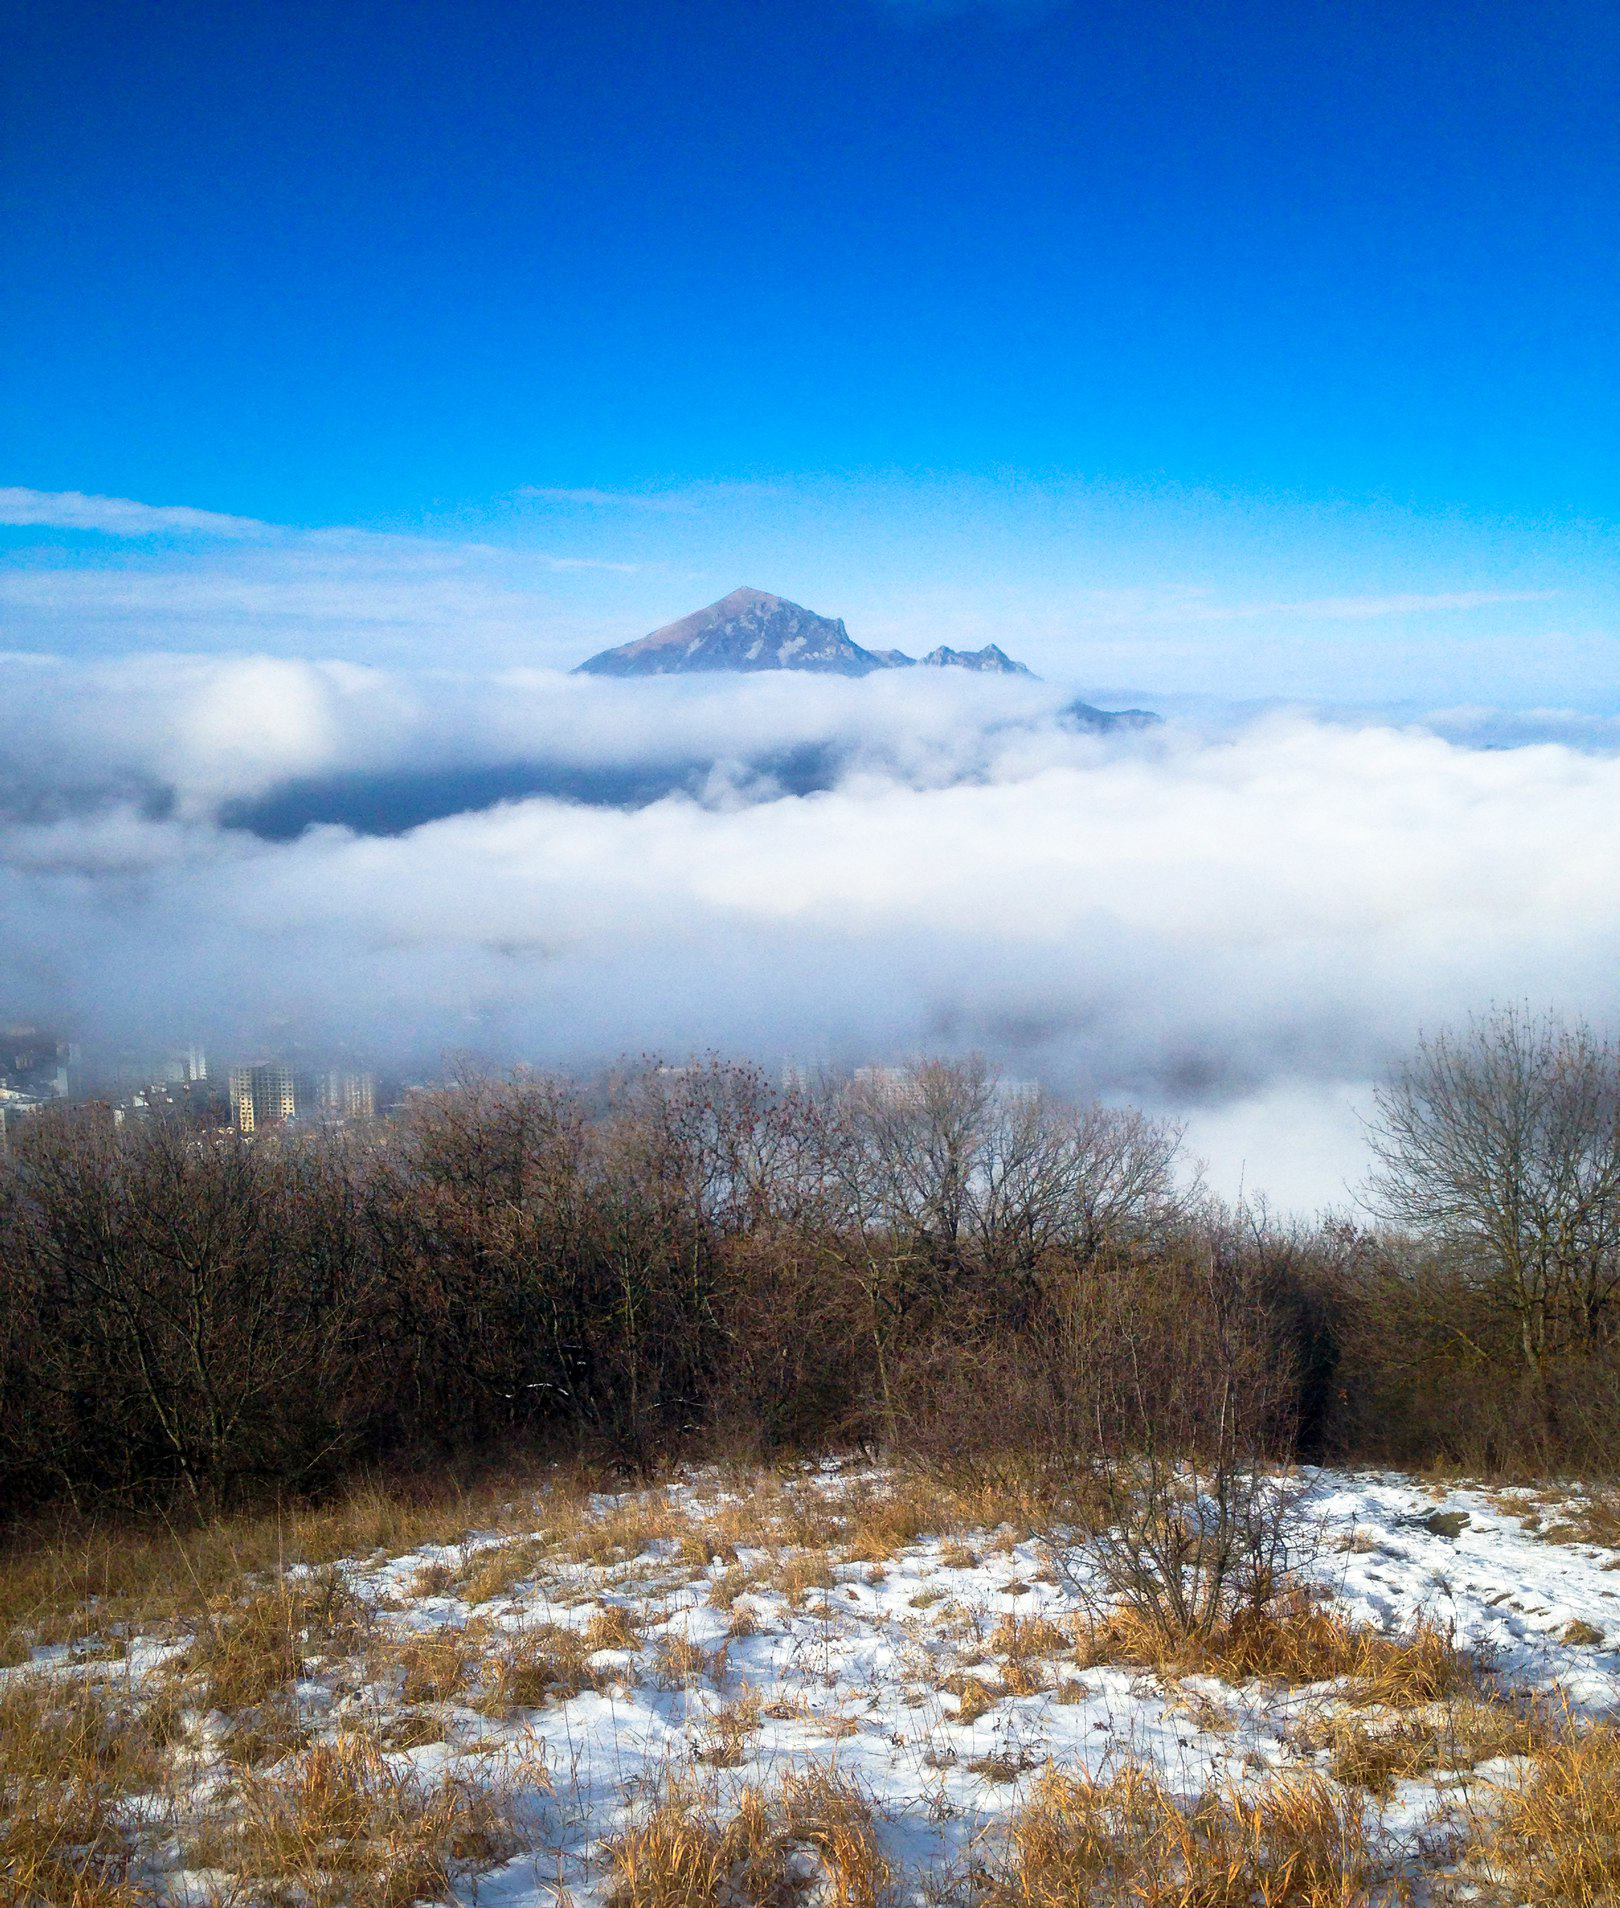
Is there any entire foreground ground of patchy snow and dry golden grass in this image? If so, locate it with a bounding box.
[0,1465,1620,1908]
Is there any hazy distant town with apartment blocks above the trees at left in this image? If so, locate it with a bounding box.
[0,1025,381,1149]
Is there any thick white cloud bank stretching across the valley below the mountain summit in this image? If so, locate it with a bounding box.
[0,658,1620,1198]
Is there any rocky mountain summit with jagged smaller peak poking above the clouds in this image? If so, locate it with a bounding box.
[576,588,1030,675]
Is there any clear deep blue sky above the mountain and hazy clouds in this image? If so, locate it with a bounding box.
[0,0,1620,698]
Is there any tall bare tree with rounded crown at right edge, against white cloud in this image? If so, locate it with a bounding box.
[1368,1007,1620,1376]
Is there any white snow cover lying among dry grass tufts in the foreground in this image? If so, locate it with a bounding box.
[10,1465,1620,1904]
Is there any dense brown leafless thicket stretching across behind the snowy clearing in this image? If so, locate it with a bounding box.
[0,1030,1620,1511]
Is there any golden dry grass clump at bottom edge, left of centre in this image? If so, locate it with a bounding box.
[187,1732,521,1908]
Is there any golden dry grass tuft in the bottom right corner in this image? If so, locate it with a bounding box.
[1473,1723,1620,1908]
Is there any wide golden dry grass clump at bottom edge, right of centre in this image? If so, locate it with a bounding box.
[981,1767,1374,1908]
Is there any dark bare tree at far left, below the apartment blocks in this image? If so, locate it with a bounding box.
[10,1118,364,1507]
